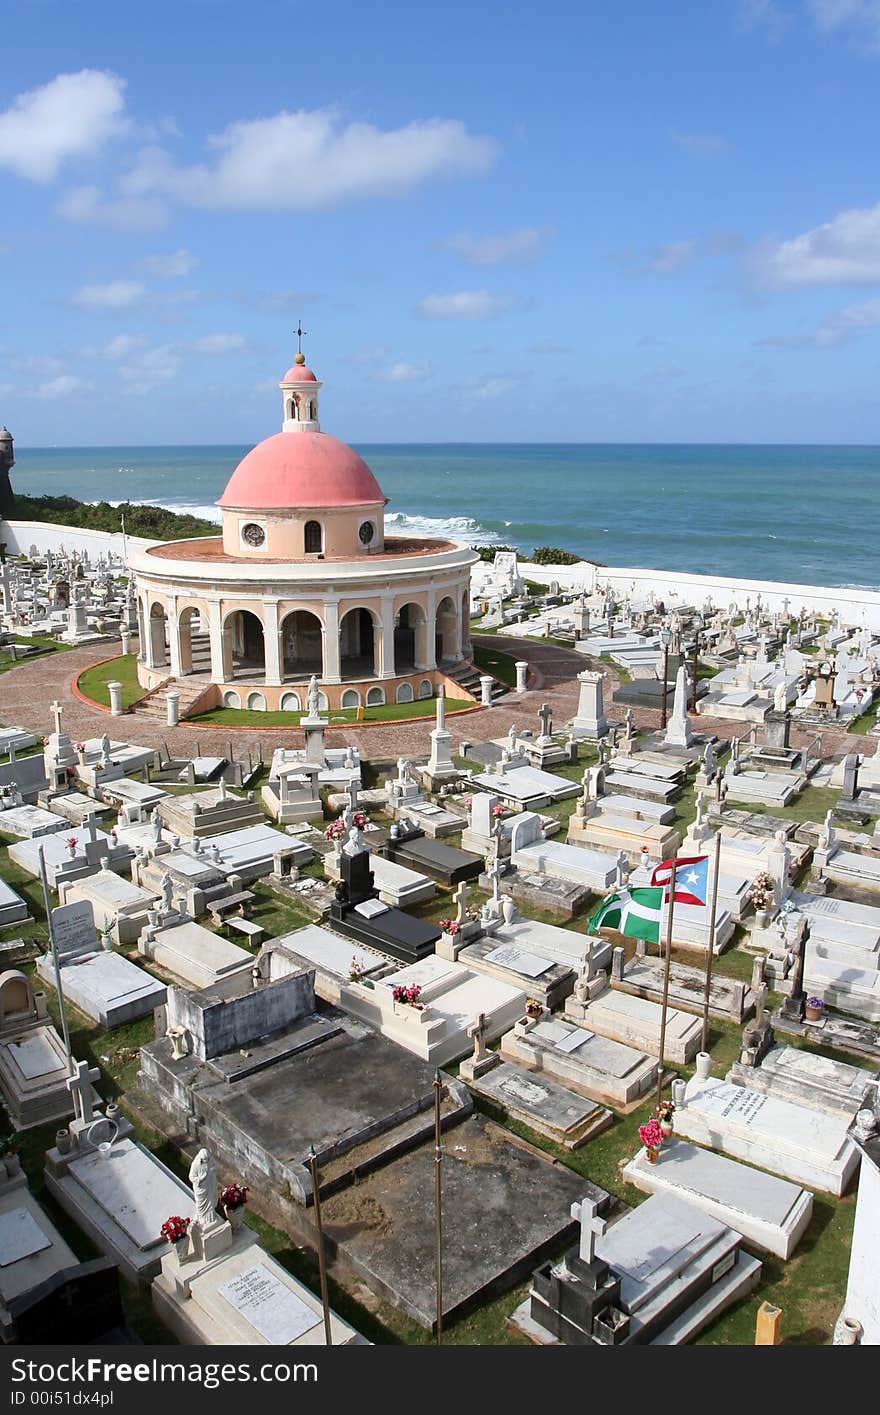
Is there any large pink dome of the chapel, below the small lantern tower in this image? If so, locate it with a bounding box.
[216,435,386,511]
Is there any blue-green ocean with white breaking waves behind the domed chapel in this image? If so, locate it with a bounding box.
[13,443,880,589]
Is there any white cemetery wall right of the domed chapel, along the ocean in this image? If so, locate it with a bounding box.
[518,560,880,633]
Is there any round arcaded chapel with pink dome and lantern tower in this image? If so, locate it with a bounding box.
[129,354,477,712]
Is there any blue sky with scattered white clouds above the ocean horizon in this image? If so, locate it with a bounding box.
[0,0,880,446]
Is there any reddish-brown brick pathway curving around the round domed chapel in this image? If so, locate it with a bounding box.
[0,634,877,760]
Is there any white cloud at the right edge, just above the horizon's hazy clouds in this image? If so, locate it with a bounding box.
[753,204,880,286]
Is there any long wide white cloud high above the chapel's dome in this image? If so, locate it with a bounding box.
[122,109,498,211]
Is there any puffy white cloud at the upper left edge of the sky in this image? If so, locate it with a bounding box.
[0,69,126,183]
